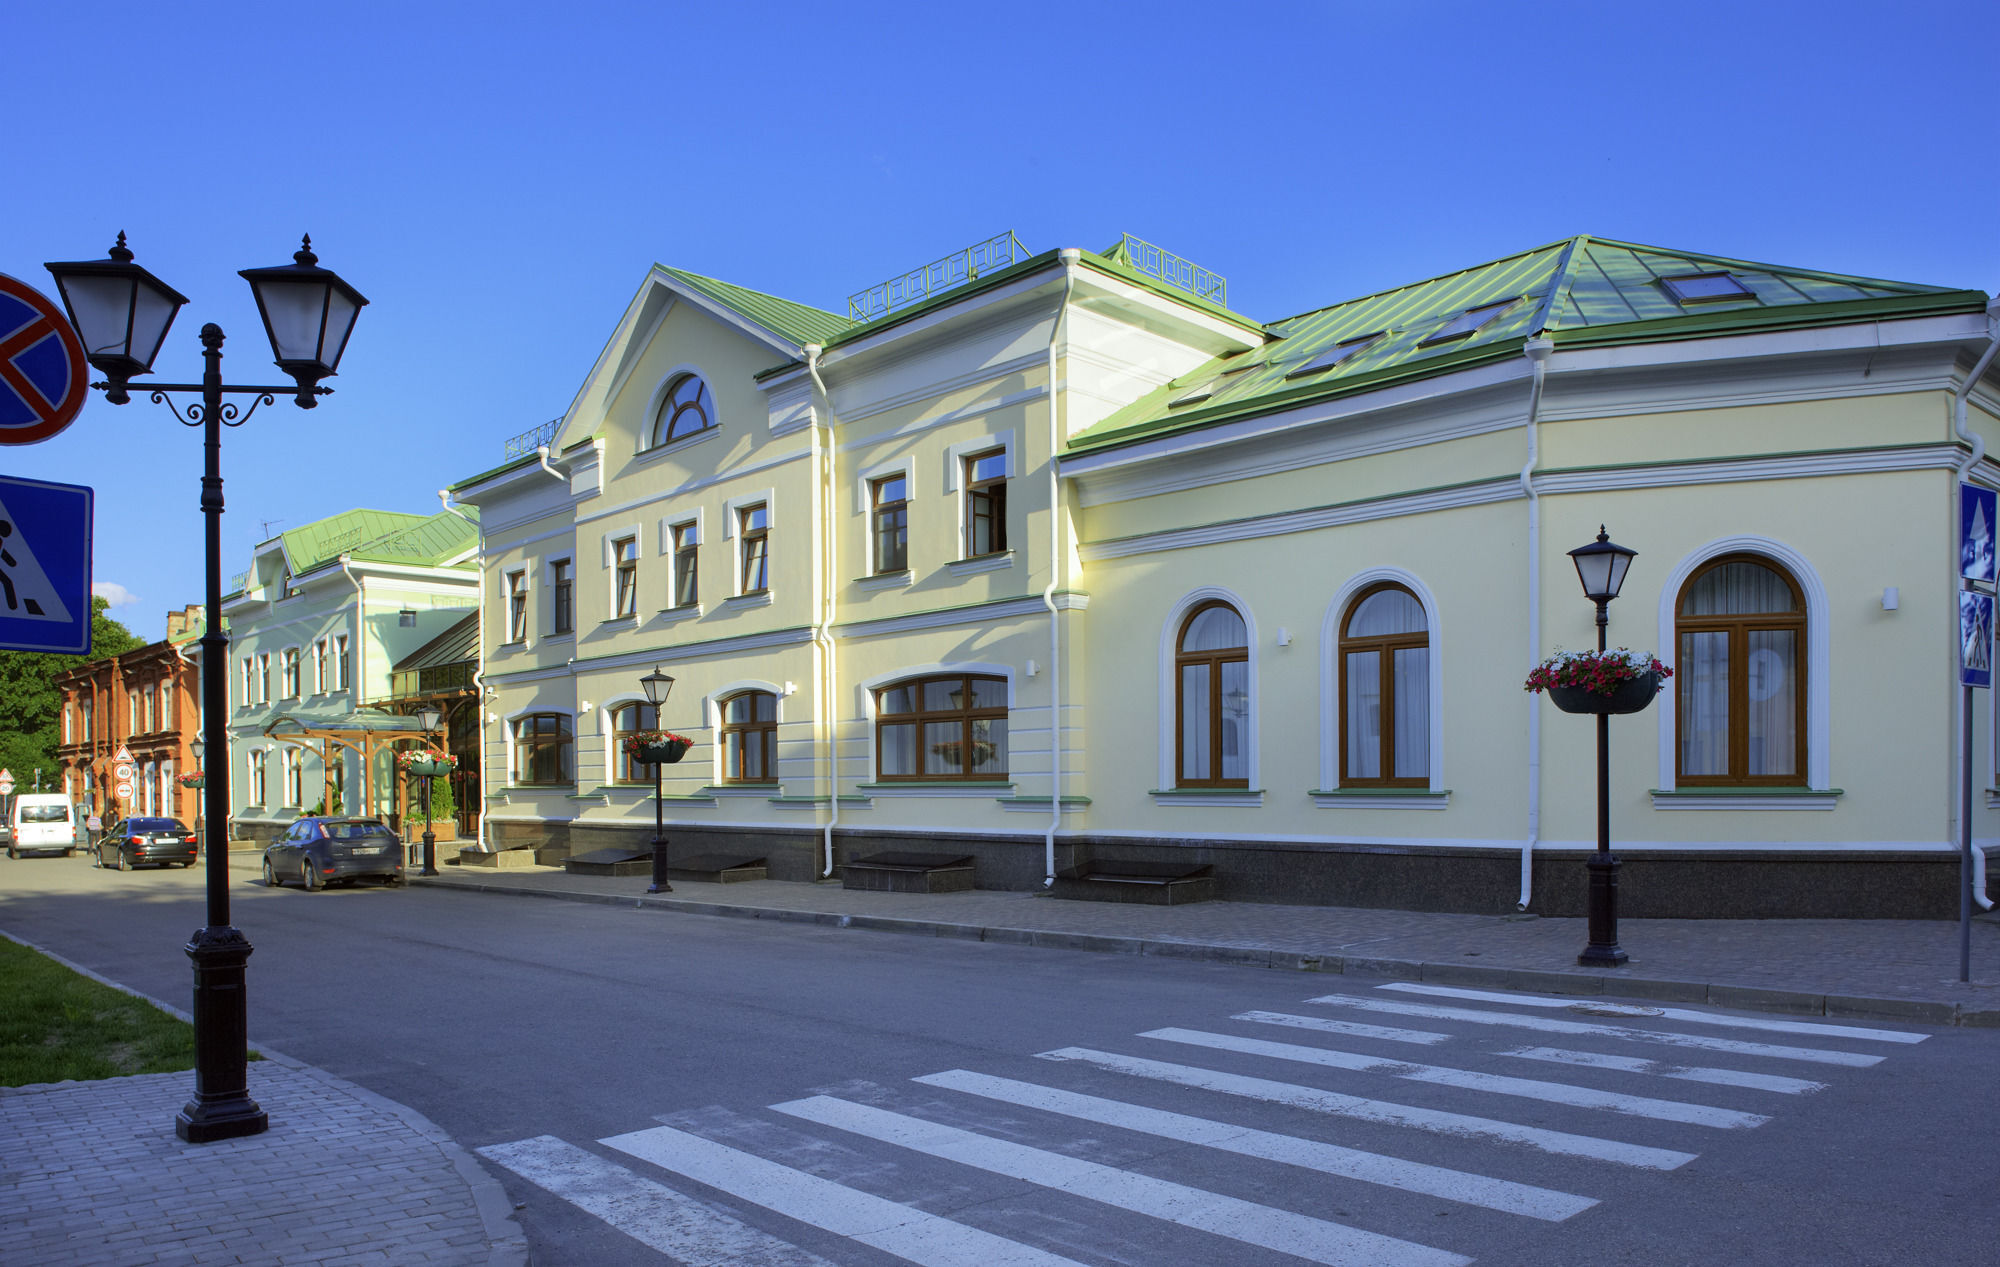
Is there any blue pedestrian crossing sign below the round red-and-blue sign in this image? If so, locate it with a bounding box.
[0,476,94,655]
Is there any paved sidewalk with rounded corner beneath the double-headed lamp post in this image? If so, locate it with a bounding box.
[0,931,528,1267]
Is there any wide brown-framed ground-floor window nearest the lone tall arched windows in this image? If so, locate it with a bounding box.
[876,673,1006,781]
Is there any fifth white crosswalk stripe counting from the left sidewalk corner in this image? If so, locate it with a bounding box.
[1040,1047,1696,1171]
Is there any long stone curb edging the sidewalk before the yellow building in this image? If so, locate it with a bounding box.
[408,875,2000,1029]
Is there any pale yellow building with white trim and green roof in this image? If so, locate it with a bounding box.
[452,236,2000,915]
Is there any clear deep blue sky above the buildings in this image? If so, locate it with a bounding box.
[0,0,2000,637]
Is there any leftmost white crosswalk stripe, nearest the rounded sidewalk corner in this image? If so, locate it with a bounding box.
[478,1135,832,1267]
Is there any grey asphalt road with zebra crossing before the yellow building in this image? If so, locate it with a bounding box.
[0,859,2000,1267]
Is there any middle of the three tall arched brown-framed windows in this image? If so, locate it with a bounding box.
[1338,586,1430,787]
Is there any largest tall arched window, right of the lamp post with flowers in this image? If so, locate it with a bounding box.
[1674,554,1806,787]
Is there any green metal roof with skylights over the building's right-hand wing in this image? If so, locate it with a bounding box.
[1068,236,1986,452]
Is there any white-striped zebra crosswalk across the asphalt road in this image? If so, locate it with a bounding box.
[478,981,1928,1267]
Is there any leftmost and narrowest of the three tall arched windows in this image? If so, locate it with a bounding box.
[1174,602,1250,787]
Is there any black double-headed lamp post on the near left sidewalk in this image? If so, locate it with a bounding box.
[46,234,368,1143]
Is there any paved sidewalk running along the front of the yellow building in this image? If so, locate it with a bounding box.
[410,865,2000,1027]
